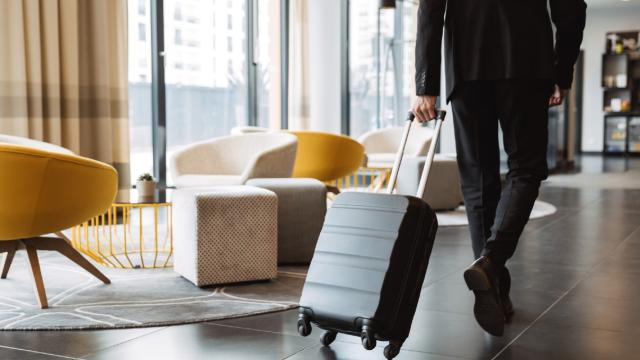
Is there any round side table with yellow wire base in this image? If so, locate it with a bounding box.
[71,189,173,269]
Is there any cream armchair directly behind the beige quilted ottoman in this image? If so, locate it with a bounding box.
[169,133,297,188]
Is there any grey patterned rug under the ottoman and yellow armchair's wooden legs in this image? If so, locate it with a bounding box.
[0,252,306,330]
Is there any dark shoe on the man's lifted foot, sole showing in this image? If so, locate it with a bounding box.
[464,269,505,336]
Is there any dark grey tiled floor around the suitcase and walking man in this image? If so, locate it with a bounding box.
[0,158,640,360]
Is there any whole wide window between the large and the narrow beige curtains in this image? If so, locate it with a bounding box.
[129,0,280,185]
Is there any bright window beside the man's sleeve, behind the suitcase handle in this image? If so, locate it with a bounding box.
[349,0,417,137]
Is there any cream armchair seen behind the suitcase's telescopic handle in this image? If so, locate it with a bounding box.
[358,122,433,168]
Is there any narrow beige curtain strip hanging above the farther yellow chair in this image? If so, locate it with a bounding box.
[289,0,311,130]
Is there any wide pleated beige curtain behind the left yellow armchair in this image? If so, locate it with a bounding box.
[0,0,130,187]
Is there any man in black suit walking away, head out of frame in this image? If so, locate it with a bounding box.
[413,0,586,336]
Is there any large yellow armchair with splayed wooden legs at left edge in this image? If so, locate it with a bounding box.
[0,137,118,308]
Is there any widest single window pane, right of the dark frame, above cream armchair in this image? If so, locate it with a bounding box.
[164,0,247,184]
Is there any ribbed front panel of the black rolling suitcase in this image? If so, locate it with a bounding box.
[300,193,409,322]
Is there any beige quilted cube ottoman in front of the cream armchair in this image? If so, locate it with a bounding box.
[173,186,278,286]
